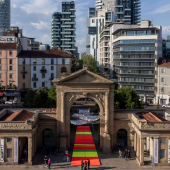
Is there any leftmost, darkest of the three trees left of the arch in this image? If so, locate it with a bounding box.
[23,88,36,108]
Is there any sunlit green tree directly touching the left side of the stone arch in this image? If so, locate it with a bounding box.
[48,86,57,108]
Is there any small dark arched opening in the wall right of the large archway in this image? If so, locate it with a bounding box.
[117,129,127,147]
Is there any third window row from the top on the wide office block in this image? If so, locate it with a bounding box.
[114,46,155,51]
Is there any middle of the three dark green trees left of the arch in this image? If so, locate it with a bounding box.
[33,87,48,108]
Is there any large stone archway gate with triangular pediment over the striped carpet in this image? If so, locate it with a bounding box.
[53,69,114,152]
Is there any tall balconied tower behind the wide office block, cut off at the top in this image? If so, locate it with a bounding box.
[96,0,141,24]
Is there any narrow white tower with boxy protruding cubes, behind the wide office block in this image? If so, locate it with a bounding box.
[86,7,117,65]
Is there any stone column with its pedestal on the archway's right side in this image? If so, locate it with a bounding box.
[103,92,111,153]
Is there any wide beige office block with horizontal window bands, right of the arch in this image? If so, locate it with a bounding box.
[100,21,162,104]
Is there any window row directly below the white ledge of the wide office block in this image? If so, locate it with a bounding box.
[114,39,155,46]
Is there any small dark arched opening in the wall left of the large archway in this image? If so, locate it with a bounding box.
[43,129,54,147]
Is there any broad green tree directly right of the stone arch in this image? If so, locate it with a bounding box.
[114,87,143,109]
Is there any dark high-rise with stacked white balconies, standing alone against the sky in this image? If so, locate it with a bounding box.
[52,1,76,53]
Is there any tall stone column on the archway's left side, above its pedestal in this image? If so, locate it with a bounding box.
[61,93,65,134]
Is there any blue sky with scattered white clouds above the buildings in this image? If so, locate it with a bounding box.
[11,0,170,52]
